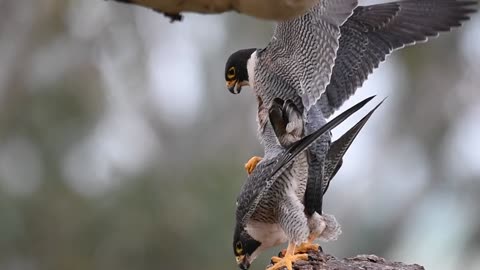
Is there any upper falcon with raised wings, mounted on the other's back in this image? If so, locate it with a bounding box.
[225,0,476,214]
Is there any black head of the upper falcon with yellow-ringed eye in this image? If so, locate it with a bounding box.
[225,48,257,94]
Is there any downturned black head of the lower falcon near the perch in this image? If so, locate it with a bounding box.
[233,224,262,270]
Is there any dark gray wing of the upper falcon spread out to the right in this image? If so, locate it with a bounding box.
[320,0,476,117]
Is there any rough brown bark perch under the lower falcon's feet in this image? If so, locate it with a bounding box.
[269,251,425,270]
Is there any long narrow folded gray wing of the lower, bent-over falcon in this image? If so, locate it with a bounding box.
[236,96,376,224]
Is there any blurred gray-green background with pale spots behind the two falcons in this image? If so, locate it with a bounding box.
[0,0,480,270]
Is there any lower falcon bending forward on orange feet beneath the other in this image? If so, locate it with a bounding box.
[233,97,381,270]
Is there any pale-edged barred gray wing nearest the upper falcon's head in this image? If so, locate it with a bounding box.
[255,0,357,110]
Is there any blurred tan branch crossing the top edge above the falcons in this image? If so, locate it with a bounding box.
[110,0,315,20]
